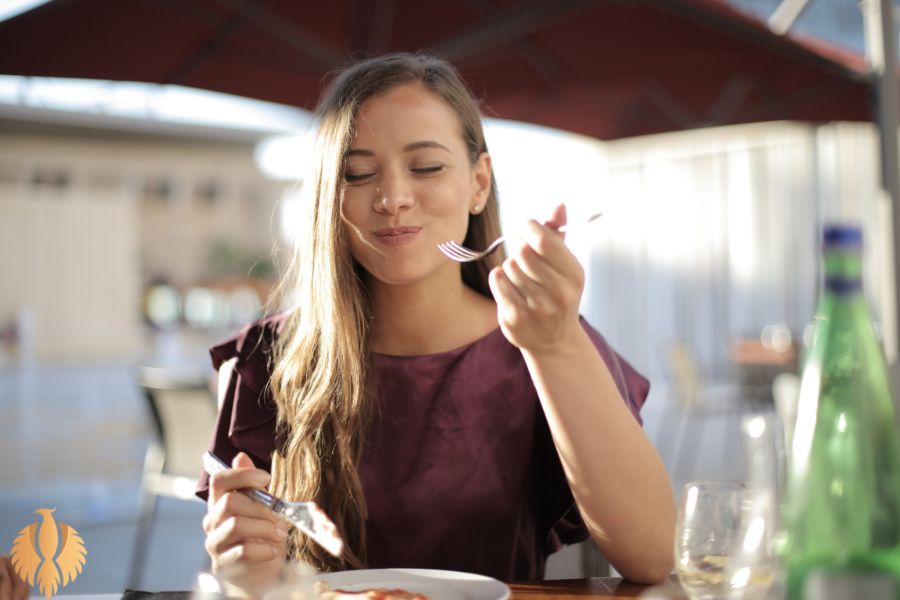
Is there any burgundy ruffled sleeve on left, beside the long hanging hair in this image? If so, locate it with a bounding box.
[196,315,286,500]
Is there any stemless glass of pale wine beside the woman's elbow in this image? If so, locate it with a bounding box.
[675,481,744,600]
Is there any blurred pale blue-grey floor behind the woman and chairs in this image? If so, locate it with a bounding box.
[0,356,740,594]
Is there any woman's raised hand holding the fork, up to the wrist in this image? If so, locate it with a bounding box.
[490,204,584,353]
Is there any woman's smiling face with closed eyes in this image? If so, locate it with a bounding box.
[341,84,490,284]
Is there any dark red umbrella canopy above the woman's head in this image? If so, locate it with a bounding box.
[0,0,871,139]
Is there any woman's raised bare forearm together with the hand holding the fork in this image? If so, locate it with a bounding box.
[491,207,675,582]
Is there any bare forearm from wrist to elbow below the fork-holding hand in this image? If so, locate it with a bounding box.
[523,330,675,582]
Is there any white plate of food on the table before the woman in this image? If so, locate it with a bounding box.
[316,569,509,600]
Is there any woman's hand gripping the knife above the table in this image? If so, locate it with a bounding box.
[203,452,288,590]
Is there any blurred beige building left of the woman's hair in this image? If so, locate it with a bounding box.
[0,104,288,361]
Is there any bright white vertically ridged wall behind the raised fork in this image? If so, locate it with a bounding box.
[572,123,893,379]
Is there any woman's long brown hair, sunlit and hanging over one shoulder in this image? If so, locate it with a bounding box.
[271,53,503,570]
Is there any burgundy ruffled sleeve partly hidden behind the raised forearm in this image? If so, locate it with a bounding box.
[535,318,650,554]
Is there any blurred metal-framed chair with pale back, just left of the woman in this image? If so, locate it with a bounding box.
[128,366,217,589]
